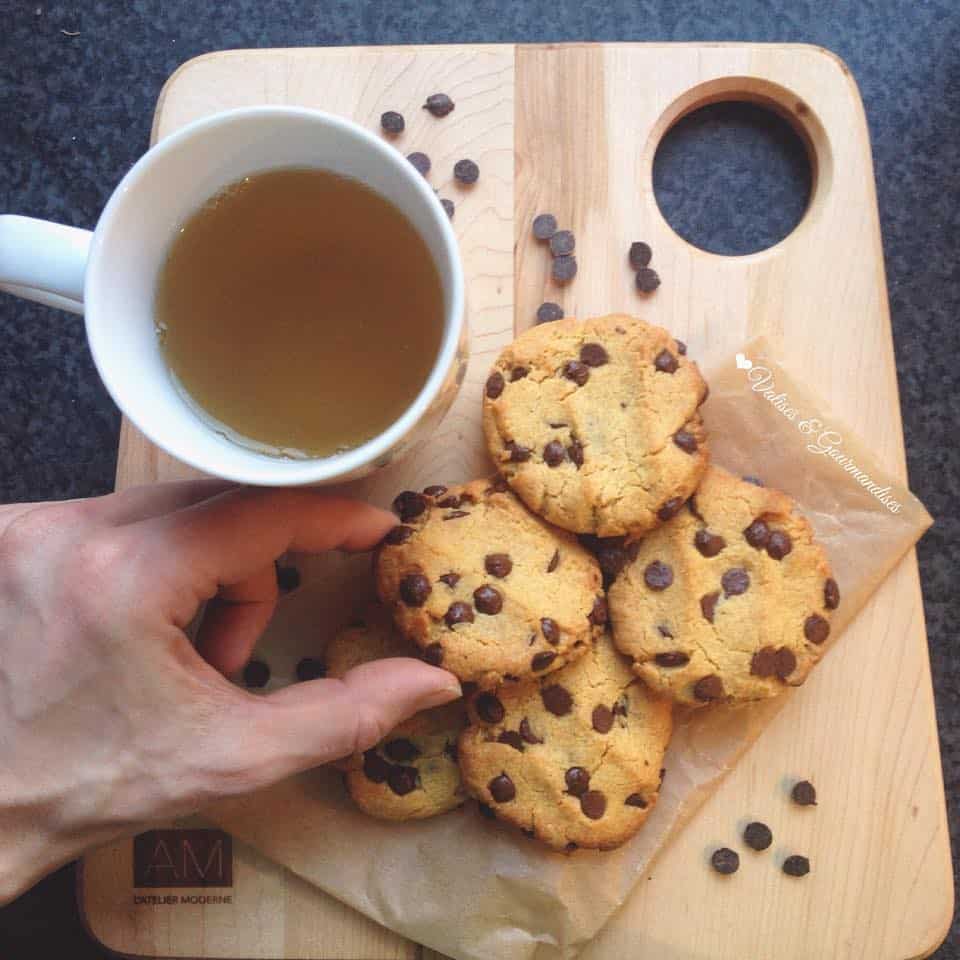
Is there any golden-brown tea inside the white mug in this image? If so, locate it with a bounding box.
[156,169,444,457]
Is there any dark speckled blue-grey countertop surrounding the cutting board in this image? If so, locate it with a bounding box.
[0,0,960,960]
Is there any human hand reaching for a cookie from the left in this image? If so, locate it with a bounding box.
[0,480,460,903]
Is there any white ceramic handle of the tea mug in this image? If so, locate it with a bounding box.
[0,214,93,313]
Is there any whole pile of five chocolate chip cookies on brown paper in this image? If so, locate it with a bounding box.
[328,315,839,850]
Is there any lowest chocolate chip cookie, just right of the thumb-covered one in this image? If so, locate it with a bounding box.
[460,633,671,850]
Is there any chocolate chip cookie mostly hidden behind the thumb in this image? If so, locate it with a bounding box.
[326,614,466,820]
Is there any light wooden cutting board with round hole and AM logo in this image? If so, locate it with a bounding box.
[80,44,953,960]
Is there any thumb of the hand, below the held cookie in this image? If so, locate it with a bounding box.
[221,657,462,789]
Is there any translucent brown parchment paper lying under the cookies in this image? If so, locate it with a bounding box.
[201,340,931,960]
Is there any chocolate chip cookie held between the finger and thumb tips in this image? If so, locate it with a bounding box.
[376,478,607,688]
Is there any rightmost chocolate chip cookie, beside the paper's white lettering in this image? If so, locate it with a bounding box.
[609,467,840,705]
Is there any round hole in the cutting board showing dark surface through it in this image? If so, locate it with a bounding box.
[653,100,813,256]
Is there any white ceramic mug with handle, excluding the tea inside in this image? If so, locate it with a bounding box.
[0,106,466,486]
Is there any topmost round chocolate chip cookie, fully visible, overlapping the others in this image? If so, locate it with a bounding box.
[483,314,708,537]
